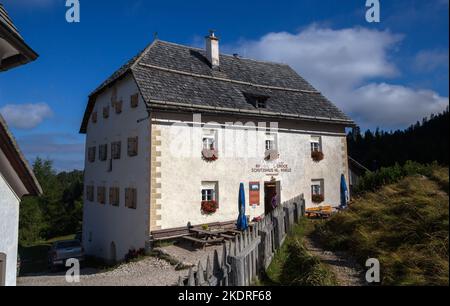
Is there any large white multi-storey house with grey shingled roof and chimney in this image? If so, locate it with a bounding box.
[81,33,353,260]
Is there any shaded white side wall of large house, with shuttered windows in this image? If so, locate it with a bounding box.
[83,77,150,260]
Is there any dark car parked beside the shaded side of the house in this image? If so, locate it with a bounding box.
[48,240,84,270]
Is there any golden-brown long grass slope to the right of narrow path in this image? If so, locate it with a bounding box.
[315,167,449,286]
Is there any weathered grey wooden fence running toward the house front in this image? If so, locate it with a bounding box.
[178,195,305,286]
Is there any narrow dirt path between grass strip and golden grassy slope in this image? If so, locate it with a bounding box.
[304,238,366,286]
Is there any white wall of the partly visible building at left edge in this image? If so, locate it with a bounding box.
[0,173,20,286]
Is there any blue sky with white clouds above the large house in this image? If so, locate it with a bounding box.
[0,0,449,170]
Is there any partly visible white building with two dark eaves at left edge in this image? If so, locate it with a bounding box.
[0,4,42,286]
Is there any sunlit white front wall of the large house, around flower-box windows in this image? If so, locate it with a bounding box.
[152,114,348,229]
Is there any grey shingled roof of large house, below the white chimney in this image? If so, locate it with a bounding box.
[80,40,353,133]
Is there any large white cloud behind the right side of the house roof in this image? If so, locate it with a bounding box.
[230,25,448,128]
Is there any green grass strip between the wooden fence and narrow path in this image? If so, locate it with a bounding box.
[258,220,337,286]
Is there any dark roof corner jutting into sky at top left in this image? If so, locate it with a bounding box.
[0,3,38,71]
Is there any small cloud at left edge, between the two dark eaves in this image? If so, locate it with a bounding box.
[0,103,53,129]
